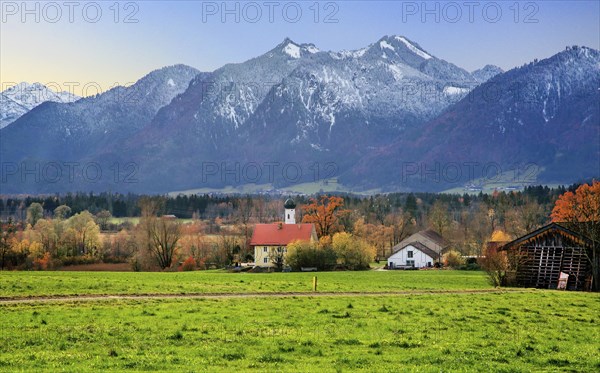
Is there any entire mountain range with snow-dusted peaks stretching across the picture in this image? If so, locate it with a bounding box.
[0,36,600,193]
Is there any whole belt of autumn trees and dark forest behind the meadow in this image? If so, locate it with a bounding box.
[0,185,592,270]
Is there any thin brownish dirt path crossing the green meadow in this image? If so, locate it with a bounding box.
[0,289,532,305]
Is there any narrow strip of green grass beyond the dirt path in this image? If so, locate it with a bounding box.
[0,270,491,298]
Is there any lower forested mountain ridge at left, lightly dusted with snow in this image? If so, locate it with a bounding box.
[0,65,199,187]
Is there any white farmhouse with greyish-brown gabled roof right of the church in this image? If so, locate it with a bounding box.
[387,229,448,269]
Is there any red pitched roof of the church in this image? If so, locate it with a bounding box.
[250,223,316,246]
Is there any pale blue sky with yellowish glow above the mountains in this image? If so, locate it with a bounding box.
[0,0,600,96]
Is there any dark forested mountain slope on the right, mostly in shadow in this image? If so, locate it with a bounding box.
[342,47,600,190]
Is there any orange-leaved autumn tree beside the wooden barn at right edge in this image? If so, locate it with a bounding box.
[551,180,600,291]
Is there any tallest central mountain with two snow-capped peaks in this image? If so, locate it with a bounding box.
[124,36,478,188]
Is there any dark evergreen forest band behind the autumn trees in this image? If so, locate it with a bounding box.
[0,184,580,221]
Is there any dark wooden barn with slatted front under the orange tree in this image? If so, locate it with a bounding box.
[500,223,593,290]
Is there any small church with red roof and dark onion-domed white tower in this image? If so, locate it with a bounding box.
[250,199,318,267]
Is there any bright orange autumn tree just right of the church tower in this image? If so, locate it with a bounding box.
[302,195,347,237]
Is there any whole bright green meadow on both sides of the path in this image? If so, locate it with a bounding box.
[0,271,600,372]
